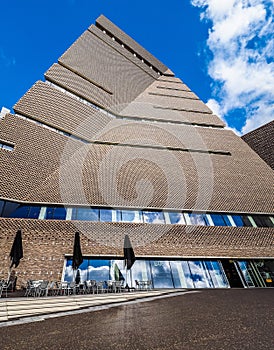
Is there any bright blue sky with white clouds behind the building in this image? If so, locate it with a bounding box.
[0,0,274,135]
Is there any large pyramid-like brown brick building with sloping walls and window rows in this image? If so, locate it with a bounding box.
[0,16,274,288]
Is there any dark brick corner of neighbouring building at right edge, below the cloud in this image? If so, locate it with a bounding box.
[242,121,274,169]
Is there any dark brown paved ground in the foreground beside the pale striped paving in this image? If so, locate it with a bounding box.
[0,288,274,350]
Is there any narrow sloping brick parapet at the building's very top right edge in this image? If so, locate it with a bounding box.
[95,15,172,74]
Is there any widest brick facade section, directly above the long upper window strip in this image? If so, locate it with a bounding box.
[0,111,273,213]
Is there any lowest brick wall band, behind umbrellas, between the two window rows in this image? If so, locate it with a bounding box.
[0,218,274,286]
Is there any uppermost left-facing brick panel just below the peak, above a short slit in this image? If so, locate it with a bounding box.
[59,31,154,106]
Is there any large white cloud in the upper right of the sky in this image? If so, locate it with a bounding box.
[191,0,274,133]
